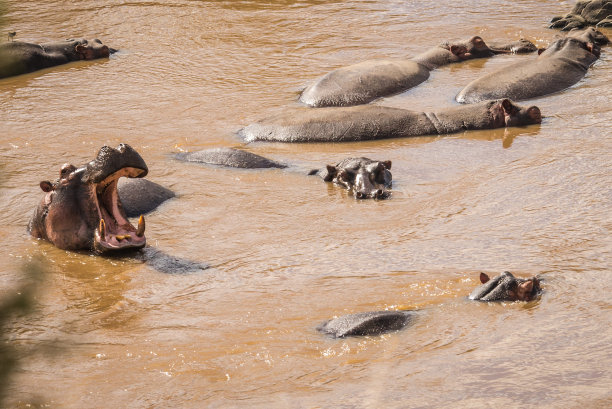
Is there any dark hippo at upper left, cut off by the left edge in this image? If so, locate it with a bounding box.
[0,39,116,78]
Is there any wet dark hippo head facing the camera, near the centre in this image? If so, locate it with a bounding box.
[309,158,392,199]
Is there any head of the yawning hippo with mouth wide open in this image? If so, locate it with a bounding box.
[28,144,148,253]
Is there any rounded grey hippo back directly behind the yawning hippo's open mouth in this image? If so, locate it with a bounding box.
[117,178,175,217]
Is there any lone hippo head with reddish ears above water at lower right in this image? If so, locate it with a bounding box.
[469,271,541,301]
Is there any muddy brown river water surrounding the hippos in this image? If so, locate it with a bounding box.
[0,0,612,408]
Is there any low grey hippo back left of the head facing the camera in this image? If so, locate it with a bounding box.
[174,148,287,169]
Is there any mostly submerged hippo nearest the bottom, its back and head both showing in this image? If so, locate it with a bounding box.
[317,271,541,338]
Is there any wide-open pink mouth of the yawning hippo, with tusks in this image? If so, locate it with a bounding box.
[91,167,147,253]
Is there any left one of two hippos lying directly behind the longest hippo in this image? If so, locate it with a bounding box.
[300,36,537,107]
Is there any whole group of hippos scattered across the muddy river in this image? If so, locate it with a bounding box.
[0,0,612,337]
